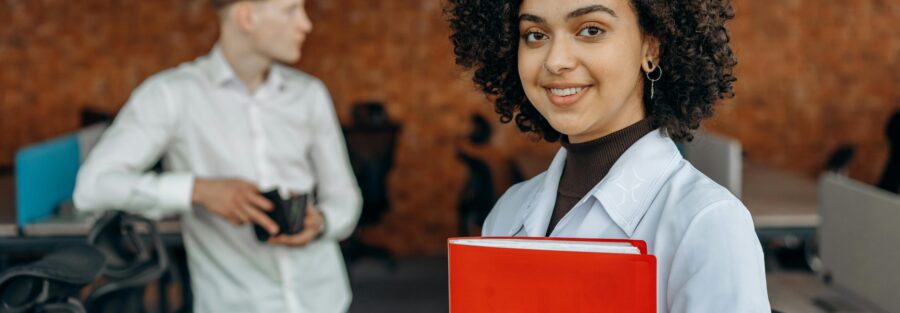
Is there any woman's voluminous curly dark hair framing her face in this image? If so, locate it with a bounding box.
[444,0,737,142]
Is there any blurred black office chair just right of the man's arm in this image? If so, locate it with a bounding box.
[341,102,400,268]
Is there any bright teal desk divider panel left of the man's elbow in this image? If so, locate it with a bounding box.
[15,123,106,227]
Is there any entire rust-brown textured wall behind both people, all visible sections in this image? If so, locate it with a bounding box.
[0,0,900,254]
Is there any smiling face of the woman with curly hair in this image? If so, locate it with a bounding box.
[518,0,657,143]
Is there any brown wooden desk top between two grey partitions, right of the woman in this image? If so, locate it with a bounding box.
[741,162,819,229]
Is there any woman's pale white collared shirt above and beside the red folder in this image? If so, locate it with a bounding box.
[483,130,771,313]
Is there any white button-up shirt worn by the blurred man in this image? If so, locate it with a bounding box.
[74,48,361,313]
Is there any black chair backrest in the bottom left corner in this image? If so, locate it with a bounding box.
[0,245,104,313]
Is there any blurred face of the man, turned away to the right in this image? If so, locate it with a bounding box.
[250,0,312,64]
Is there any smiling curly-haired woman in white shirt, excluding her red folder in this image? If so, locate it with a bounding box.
[447,0,770,313]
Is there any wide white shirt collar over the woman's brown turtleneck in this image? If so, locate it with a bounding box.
[513,130,682,237]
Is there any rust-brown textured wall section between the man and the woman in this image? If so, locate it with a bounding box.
[299,0,549,254]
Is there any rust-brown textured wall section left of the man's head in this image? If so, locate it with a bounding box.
[0,0,216,165]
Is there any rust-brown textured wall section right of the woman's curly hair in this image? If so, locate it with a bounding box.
[709,0,900,182]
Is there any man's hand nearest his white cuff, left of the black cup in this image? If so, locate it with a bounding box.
[191,179,278,235]
